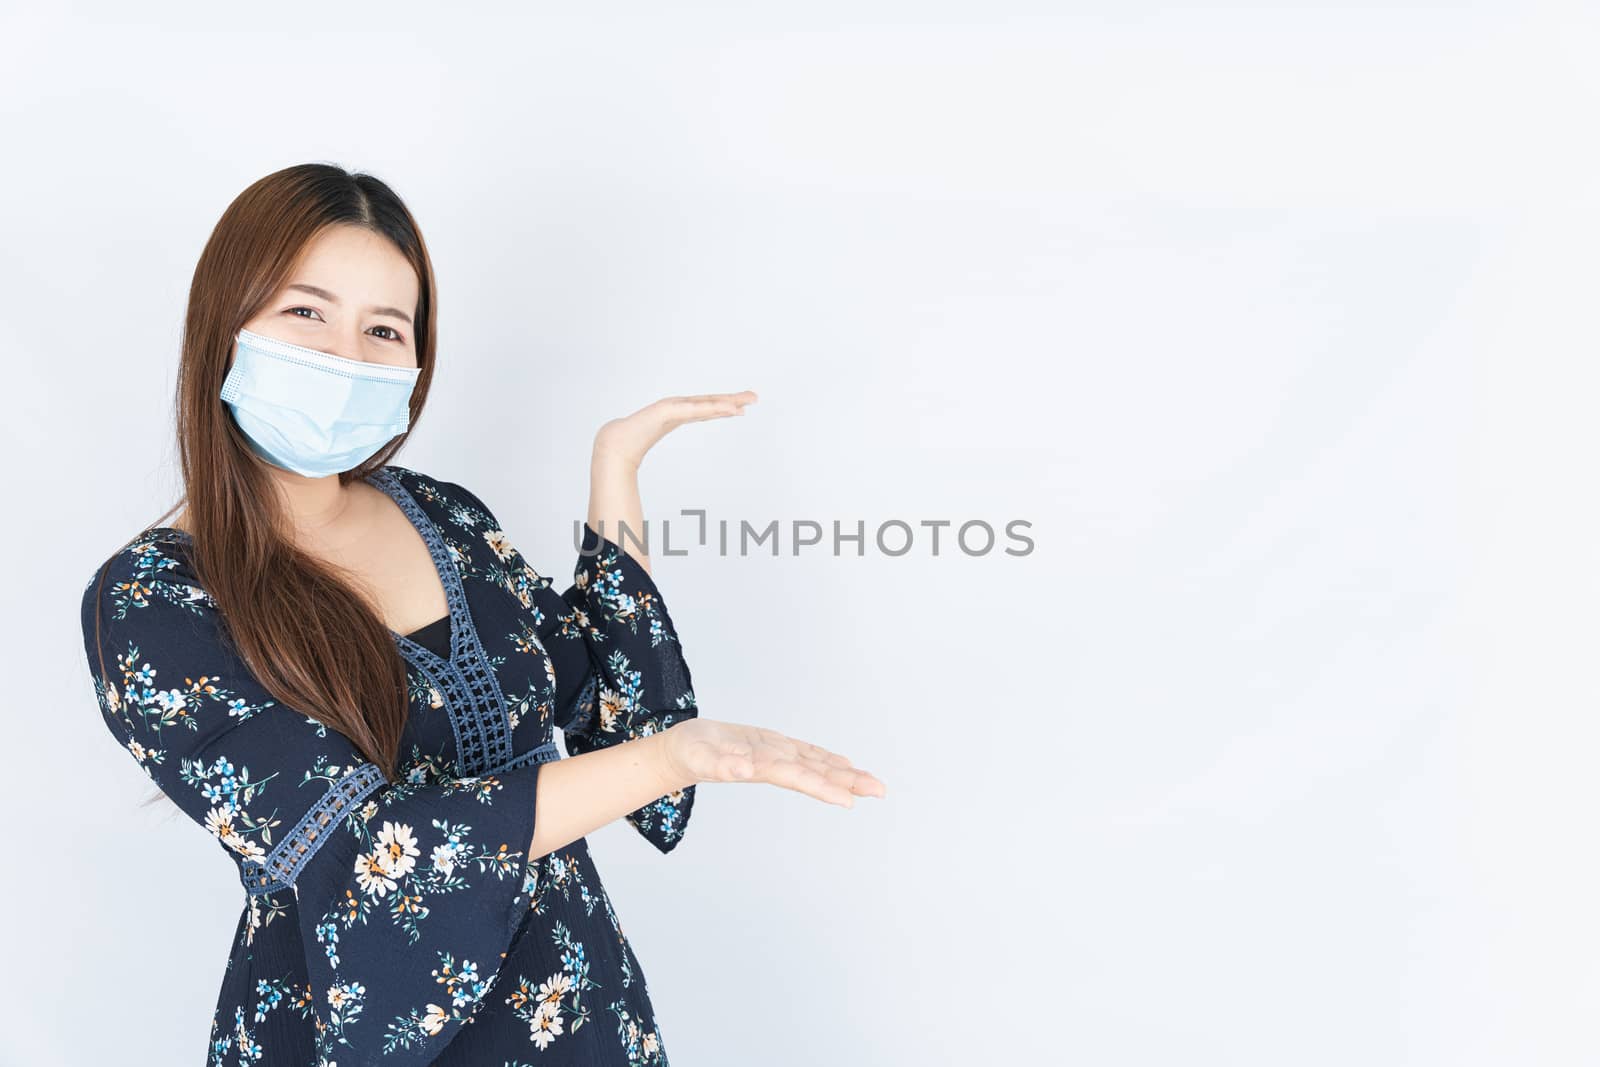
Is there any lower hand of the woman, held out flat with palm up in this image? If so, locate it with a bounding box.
[661,718,888,808]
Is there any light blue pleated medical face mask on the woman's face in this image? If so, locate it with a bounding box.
[221,330,422,478]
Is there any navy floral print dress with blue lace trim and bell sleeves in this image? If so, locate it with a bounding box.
[82,464,696,1067]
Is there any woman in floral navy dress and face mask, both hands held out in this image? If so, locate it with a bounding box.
[83,165,885,1067]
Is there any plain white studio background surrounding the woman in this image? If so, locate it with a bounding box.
[0,2,1600,1067]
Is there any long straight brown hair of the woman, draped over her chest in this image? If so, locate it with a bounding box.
[96,163,435,803]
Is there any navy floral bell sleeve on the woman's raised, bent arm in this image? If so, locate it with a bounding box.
[555,523,699,853]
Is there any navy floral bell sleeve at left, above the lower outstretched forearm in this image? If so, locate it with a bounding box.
[82,541,541,1067]
